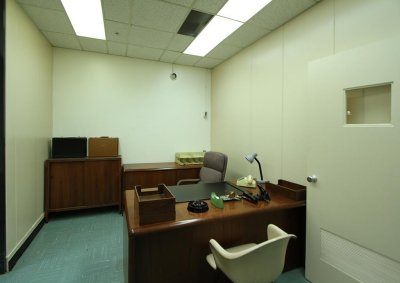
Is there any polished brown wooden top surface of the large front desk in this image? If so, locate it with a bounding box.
[124,183,306,236]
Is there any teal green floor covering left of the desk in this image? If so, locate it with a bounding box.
[0,210,308,283]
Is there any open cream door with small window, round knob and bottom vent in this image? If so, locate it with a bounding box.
[306,38,400,283]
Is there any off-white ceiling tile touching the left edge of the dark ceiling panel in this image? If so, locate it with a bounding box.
[131,0,190,33]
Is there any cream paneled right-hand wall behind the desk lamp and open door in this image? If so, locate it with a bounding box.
[211,0,400,184]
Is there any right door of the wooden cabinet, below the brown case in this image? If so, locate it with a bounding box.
[84,160,121,206]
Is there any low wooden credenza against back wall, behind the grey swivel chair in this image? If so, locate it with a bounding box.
[122,162,202,190]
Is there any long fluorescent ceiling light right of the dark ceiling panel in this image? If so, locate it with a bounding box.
[183,0,272,56]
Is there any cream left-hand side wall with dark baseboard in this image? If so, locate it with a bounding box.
[6,0,53,260]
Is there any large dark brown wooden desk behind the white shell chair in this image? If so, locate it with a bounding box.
[123,183,306,283]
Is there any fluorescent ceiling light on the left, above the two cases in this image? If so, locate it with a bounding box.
[61,0,106,40]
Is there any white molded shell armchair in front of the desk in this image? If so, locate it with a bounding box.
[206,224,296,283]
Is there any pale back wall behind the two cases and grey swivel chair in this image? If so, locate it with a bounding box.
[53,48,211,163]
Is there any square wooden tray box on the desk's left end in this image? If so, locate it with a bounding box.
[135,184,176,225]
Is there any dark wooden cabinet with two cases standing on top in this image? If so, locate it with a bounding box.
[45,157,121,221]
